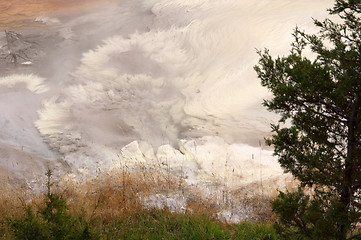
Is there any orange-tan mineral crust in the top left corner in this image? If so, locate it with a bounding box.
[0,0,114,30]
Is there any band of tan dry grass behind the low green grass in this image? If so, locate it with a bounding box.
[0,165,294,239]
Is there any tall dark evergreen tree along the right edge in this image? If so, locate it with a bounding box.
[255,0,361,240]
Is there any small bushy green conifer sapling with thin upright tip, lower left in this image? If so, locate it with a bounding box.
[7,170,99,240]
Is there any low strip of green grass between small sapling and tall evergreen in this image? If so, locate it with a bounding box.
[104,209,280,240]
